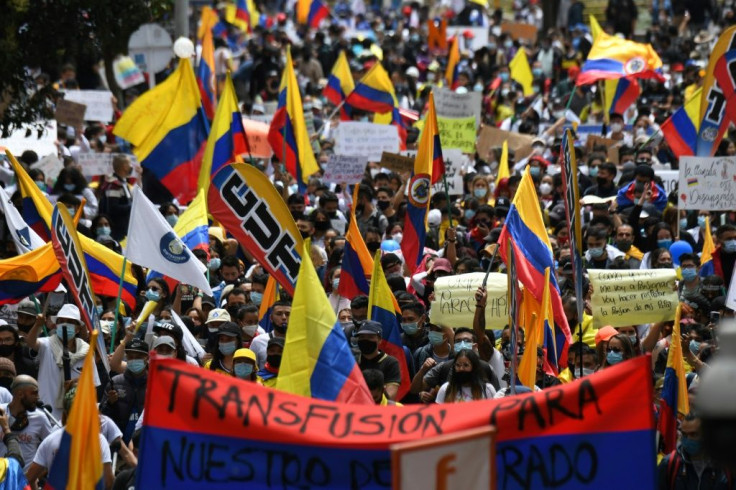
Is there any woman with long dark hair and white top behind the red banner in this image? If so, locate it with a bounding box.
[436,349,496,403]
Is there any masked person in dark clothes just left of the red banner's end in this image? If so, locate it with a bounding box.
[100,338,149,443]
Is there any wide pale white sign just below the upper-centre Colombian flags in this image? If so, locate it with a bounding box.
[335,121,399,162]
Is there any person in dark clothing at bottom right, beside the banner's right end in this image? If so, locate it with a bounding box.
[657,412,733,489]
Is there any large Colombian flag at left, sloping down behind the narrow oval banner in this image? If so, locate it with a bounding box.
[6,151,138,308]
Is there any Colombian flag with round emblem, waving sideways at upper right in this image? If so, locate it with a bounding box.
[576,32,663,85]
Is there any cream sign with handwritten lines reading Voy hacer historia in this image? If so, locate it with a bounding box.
[588,269,678,327]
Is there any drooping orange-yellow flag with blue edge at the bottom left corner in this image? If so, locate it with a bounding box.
[44,330,105,490]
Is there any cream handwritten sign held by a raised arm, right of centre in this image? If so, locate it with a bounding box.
[429,272,509,330]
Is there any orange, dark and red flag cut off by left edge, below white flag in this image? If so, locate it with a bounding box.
[0,243,61,305]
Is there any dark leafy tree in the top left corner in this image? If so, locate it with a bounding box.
[0,0,174,136]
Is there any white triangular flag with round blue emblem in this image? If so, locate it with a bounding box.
[124,187,212,296]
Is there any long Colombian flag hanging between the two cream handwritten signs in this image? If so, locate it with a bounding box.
[498,169,572,373]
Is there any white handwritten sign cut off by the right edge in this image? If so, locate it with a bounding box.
[677,157,736,211]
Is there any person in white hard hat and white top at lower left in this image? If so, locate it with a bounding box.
[26,303,100,419]
